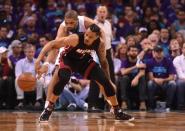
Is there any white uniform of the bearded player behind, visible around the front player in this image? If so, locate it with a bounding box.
[55,16,86,65]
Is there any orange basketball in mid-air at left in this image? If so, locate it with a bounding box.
[17,72,36,91]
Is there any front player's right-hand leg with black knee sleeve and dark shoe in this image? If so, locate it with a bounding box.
[89,65,134,121]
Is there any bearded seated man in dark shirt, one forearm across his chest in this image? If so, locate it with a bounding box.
[118,46,147,110]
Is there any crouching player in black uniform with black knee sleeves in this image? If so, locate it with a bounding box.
[35,24,134,122]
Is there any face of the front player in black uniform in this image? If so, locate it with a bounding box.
[84,29,98,46]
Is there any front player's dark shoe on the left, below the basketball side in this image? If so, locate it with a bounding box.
[39,105,54,123]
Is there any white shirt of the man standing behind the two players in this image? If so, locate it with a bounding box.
[95,19,113,50]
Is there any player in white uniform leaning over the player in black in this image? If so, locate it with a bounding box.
[36,10,104,105]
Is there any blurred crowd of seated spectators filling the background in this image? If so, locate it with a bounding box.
[0,0,185,111]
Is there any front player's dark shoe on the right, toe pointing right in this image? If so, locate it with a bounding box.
[113,109,135,121]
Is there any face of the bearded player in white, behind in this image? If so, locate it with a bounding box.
[65,18,78,31]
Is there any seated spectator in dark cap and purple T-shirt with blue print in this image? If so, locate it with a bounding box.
[147,45,176,111]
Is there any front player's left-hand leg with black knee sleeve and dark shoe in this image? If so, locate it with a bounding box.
[39,68,71,122]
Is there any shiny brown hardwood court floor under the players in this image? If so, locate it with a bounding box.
[0,112,185,131]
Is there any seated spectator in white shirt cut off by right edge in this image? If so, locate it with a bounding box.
[173,43,185,110]
